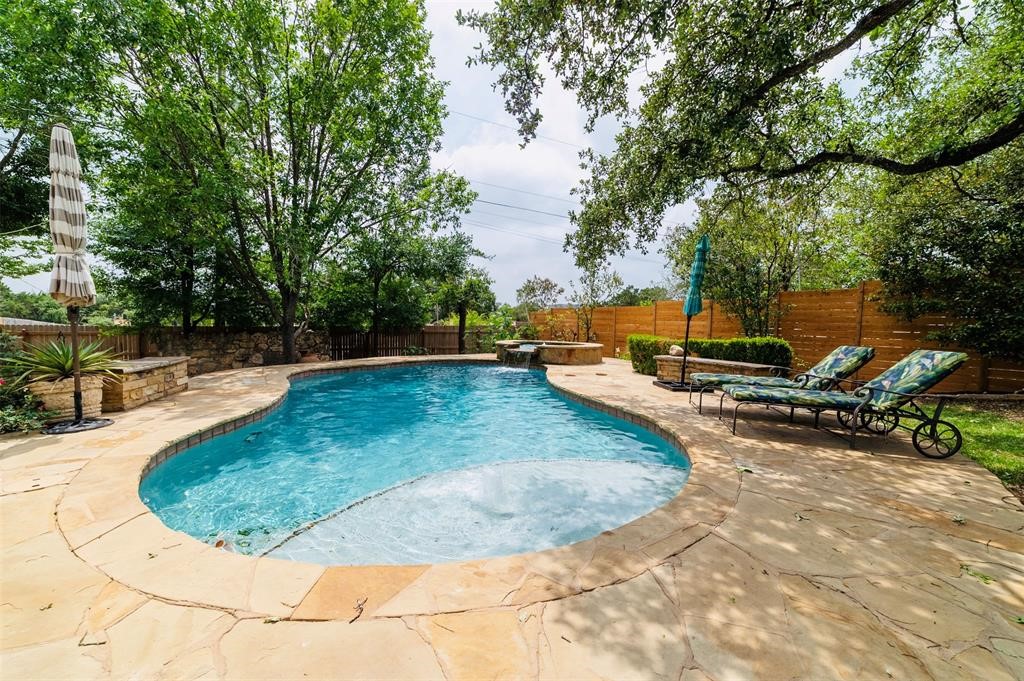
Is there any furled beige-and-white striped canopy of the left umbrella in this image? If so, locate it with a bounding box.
[50,123,96,307]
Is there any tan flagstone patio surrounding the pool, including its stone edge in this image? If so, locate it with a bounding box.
[0,356,1024,681]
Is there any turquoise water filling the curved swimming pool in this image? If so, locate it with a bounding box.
[139,365,689,564]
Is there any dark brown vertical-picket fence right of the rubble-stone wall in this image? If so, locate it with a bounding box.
[328,326,482,359]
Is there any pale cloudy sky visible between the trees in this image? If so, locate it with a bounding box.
[4,0,692,303]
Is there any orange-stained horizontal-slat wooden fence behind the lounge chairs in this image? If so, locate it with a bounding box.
[530,282,1024,392]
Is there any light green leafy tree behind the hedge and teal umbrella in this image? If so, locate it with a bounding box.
[665,177,870,336]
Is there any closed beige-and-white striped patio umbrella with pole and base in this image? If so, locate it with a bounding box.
[43,124,113,434]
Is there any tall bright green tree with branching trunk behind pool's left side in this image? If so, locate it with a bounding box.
[96,0,456,361]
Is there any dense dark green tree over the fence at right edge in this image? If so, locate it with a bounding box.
[858,142,1024,361]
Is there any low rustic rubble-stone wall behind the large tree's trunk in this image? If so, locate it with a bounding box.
[141,327,331,376]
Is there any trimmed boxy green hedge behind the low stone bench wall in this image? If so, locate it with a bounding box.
[627,334,793,376]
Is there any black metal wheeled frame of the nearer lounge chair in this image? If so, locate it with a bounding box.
[718,379,964,459]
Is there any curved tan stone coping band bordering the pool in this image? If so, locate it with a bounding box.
[56,356,739,621]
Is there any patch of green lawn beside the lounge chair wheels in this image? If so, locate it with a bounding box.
[942,405,1024,490]
